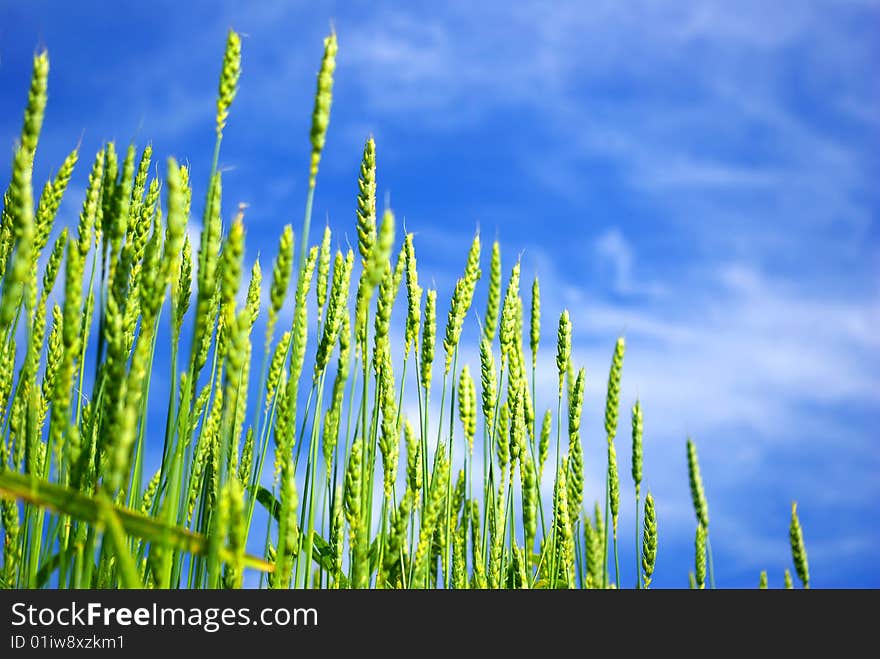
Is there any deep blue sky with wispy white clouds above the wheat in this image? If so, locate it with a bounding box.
[0,0,880,586]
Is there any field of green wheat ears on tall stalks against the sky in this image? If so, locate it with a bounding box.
[0,31,809,589]
